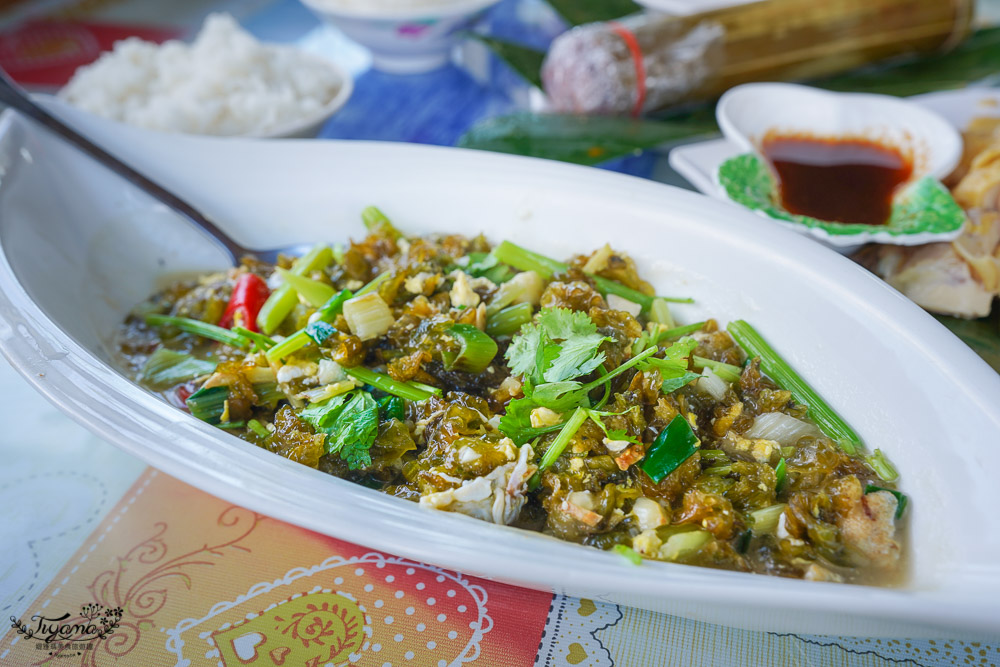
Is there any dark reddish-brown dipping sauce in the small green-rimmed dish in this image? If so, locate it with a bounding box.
[761,134,913,225]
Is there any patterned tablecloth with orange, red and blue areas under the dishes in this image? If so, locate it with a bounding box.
[0,0,1000,667]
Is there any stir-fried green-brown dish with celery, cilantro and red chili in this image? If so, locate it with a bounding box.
[120,208,906,584]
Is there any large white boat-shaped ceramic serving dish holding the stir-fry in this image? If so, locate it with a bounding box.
[0,100,1000,636]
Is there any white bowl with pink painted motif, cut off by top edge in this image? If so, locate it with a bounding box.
[302,0,499,74]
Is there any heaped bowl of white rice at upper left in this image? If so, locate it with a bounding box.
[59,14,353,138]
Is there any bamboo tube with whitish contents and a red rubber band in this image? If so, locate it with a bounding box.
[542,0,973,114]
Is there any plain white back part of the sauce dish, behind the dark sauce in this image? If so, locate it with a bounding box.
[715,83,962,181]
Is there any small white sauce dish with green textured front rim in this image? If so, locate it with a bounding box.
[713,83,966,253]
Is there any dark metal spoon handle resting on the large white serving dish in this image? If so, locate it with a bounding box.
[0,70,245,264]
